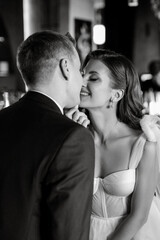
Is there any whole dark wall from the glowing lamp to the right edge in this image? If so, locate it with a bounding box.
[103,0,160,74]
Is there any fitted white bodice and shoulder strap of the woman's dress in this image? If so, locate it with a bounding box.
[92,135,145,218]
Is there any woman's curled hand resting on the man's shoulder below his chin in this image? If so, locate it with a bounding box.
[65,107,90,127]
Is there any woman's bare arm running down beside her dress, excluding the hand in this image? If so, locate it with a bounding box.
[107,141,158,240]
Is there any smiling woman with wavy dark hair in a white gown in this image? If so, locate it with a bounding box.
[66,49,160,240]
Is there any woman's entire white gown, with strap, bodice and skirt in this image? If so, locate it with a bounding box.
[90,135,160,240]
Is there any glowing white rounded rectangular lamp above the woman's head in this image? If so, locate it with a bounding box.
[93,24,106,45]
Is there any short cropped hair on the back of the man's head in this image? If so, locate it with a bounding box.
[17,31,75,85]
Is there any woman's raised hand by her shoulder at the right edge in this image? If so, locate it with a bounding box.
[140,115,160,142]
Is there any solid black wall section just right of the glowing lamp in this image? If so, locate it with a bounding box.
[104,0,137,59]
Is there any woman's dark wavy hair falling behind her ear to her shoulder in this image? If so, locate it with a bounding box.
[83,49,143,129]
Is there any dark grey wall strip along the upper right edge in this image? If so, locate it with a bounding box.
[133,0,160,74]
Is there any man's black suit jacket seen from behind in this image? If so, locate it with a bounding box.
[0,92,94,240]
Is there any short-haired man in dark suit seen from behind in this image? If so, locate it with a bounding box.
[0,31,94,240]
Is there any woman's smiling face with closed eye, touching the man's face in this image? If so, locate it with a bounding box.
[80,60,112,109]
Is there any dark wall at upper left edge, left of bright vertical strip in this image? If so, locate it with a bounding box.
[0,0,23,89]
